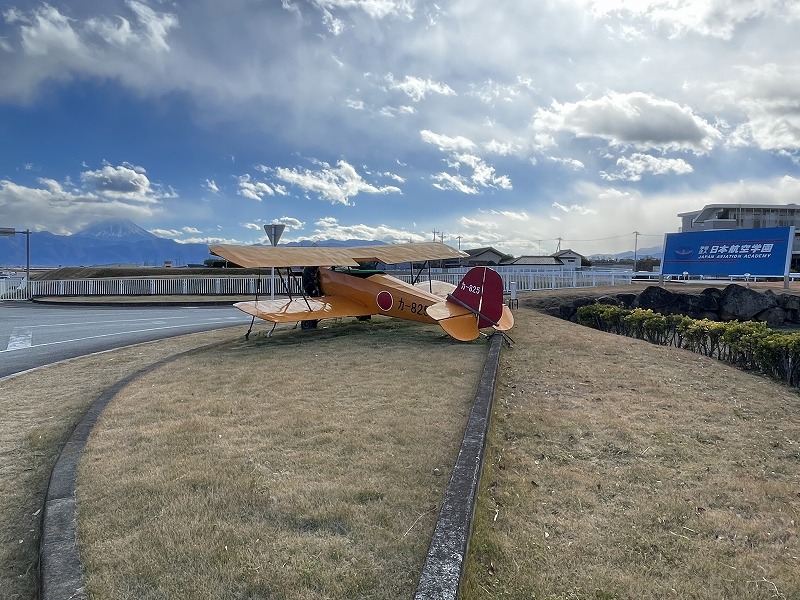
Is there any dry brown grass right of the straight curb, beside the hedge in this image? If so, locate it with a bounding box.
[464,310,800,600]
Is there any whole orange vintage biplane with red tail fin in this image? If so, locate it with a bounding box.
[209,242,514,341]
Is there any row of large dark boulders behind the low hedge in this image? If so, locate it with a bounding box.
[558,283,800,327]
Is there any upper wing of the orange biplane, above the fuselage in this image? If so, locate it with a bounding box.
[208,242,468,268]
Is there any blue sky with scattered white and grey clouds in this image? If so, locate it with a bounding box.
[0,0,800,256]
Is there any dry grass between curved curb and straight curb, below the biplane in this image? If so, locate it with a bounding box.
[78,321,487,599]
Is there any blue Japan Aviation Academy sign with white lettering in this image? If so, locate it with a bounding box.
[661,227,794,277]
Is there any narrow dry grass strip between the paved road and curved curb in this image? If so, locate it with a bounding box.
[0,328,241,599]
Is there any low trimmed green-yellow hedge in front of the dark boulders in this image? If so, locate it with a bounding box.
[577,304,800,387]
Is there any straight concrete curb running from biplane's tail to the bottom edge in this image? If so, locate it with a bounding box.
[414,333,503,600]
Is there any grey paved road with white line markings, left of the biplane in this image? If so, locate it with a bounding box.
[0,301,251,378]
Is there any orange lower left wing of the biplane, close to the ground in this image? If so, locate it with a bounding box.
[234,296,373,323]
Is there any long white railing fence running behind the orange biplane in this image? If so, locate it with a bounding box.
[0,267,631,300]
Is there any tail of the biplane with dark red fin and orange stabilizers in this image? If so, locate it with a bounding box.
[427,267,514,341]
